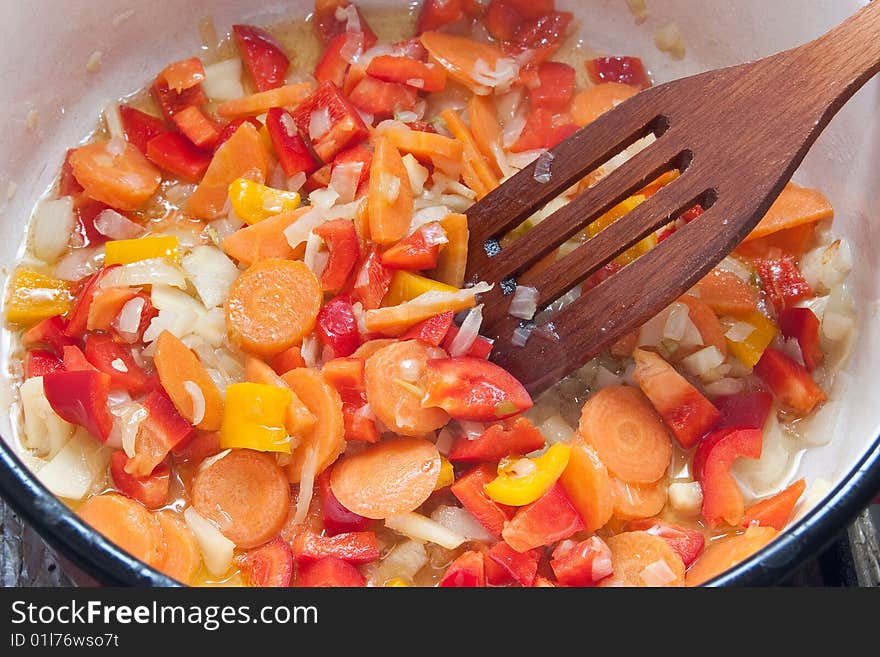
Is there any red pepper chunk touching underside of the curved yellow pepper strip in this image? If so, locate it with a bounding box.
[501,483,584,552]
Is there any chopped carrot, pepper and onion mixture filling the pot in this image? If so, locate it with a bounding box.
[5,0,853,587]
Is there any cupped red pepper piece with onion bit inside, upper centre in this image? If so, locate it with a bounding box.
[292,82,368,162]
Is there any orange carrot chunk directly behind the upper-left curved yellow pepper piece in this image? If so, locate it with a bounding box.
[188,122,269,219]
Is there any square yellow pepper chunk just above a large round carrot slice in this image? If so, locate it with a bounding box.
[220,383,292,454]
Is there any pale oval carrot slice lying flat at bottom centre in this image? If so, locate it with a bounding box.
[330,437,440,519]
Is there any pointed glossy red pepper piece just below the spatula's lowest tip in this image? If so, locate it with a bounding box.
[422,356,533,422]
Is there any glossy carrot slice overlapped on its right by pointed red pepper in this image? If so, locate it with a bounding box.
[364,340,449,436]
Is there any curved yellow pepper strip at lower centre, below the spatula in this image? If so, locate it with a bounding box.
[483,443,571,506]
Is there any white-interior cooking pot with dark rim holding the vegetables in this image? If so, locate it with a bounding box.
[0,0,880,585]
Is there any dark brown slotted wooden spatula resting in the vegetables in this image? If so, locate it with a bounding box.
[467,2,880,392]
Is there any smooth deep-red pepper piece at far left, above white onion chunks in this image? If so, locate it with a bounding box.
[43,370,113,440]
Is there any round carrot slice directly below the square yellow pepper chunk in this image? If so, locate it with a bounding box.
[192,449,290,548]
